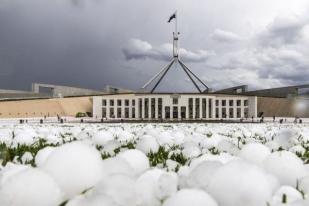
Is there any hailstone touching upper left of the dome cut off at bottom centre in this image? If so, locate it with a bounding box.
[136,168,178,206]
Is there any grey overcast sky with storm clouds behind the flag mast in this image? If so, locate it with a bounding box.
[0,0,309,91]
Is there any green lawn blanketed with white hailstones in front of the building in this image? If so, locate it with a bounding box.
[0,123,309,206]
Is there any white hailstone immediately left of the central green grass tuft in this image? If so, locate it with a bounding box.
[117,149,149,175]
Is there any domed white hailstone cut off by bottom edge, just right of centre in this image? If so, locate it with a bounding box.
[163,189,218,206]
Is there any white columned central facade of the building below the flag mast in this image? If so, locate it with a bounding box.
[93,93,257,120]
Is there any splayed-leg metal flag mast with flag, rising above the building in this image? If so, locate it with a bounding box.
[141,11,209,93]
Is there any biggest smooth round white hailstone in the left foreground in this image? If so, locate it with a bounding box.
[42,142,102,198]
